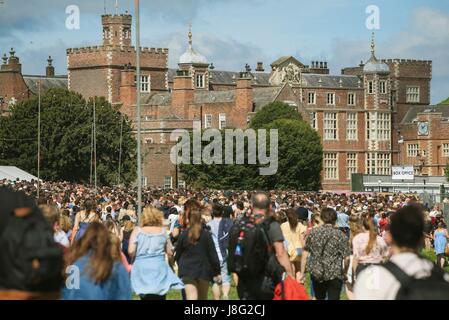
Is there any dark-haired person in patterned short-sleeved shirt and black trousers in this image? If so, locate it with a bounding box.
[301,207,351,300]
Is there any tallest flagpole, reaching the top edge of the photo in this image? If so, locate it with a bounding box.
[134,0,142,216]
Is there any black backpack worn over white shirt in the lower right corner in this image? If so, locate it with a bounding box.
[383,261,449,300]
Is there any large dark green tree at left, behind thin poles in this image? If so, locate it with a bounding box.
[0,89,136,185]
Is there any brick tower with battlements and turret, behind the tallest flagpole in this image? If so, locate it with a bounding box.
[67,14,168,116]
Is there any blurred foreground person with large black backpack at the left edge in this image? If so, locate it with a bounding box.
[0,187,64,300]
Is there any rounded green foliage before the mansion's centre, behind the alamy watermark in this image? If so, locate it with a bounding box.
[180,102,323,191]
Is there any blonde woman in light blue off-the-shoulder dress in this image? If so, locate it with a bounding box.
[128,207,184,300]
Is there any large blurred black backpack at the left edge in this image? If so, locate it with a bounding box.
[0,193,63,292]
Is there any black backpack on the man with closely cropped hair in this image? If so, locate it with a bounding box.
[227,218,268,277]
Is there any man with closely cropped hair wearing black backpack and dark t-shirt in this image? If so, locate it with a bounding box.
[228,193,295,300]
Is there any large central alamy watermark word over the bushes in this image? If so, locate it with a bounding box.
[170,129,279,176]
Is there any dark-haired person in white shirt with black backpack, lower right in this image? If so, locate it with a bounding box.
[354,204,449,300]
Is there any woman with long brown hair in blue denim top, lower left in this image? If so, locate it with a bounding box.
[62,222,132,300]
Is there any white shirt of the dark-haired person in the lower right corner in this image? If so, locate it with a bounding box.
[354,252,433,300]
